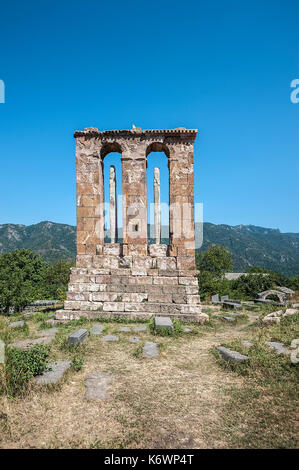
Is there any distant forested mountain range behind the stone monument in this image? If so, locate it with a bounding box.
[0,222,299,276]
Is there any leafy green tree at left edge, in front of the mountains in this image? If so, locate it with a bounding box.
[0,249,49,312]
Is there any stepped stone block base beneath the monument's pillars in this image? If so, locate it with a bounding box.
[56,248,209,323]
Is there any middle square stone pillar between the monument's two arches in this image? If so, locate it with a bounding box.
[122,149,147,254]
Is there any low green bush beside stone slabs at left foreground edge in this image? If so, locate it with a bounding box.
[0,345,50,396]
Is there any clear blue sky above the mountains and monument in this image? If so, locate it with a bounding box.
[0,0,299,232]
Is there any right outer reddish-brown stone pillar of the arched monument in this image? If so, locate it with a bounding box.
[169,142,195,269]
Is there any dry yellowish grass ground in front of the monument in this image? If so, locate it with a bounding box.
[0,308,298,449]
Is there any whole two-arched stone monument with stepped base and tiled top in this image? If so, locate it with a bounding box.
[56,127,207,322]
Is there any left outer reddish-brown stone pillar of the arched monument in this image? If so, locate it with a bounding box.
[76,136,104,255]
